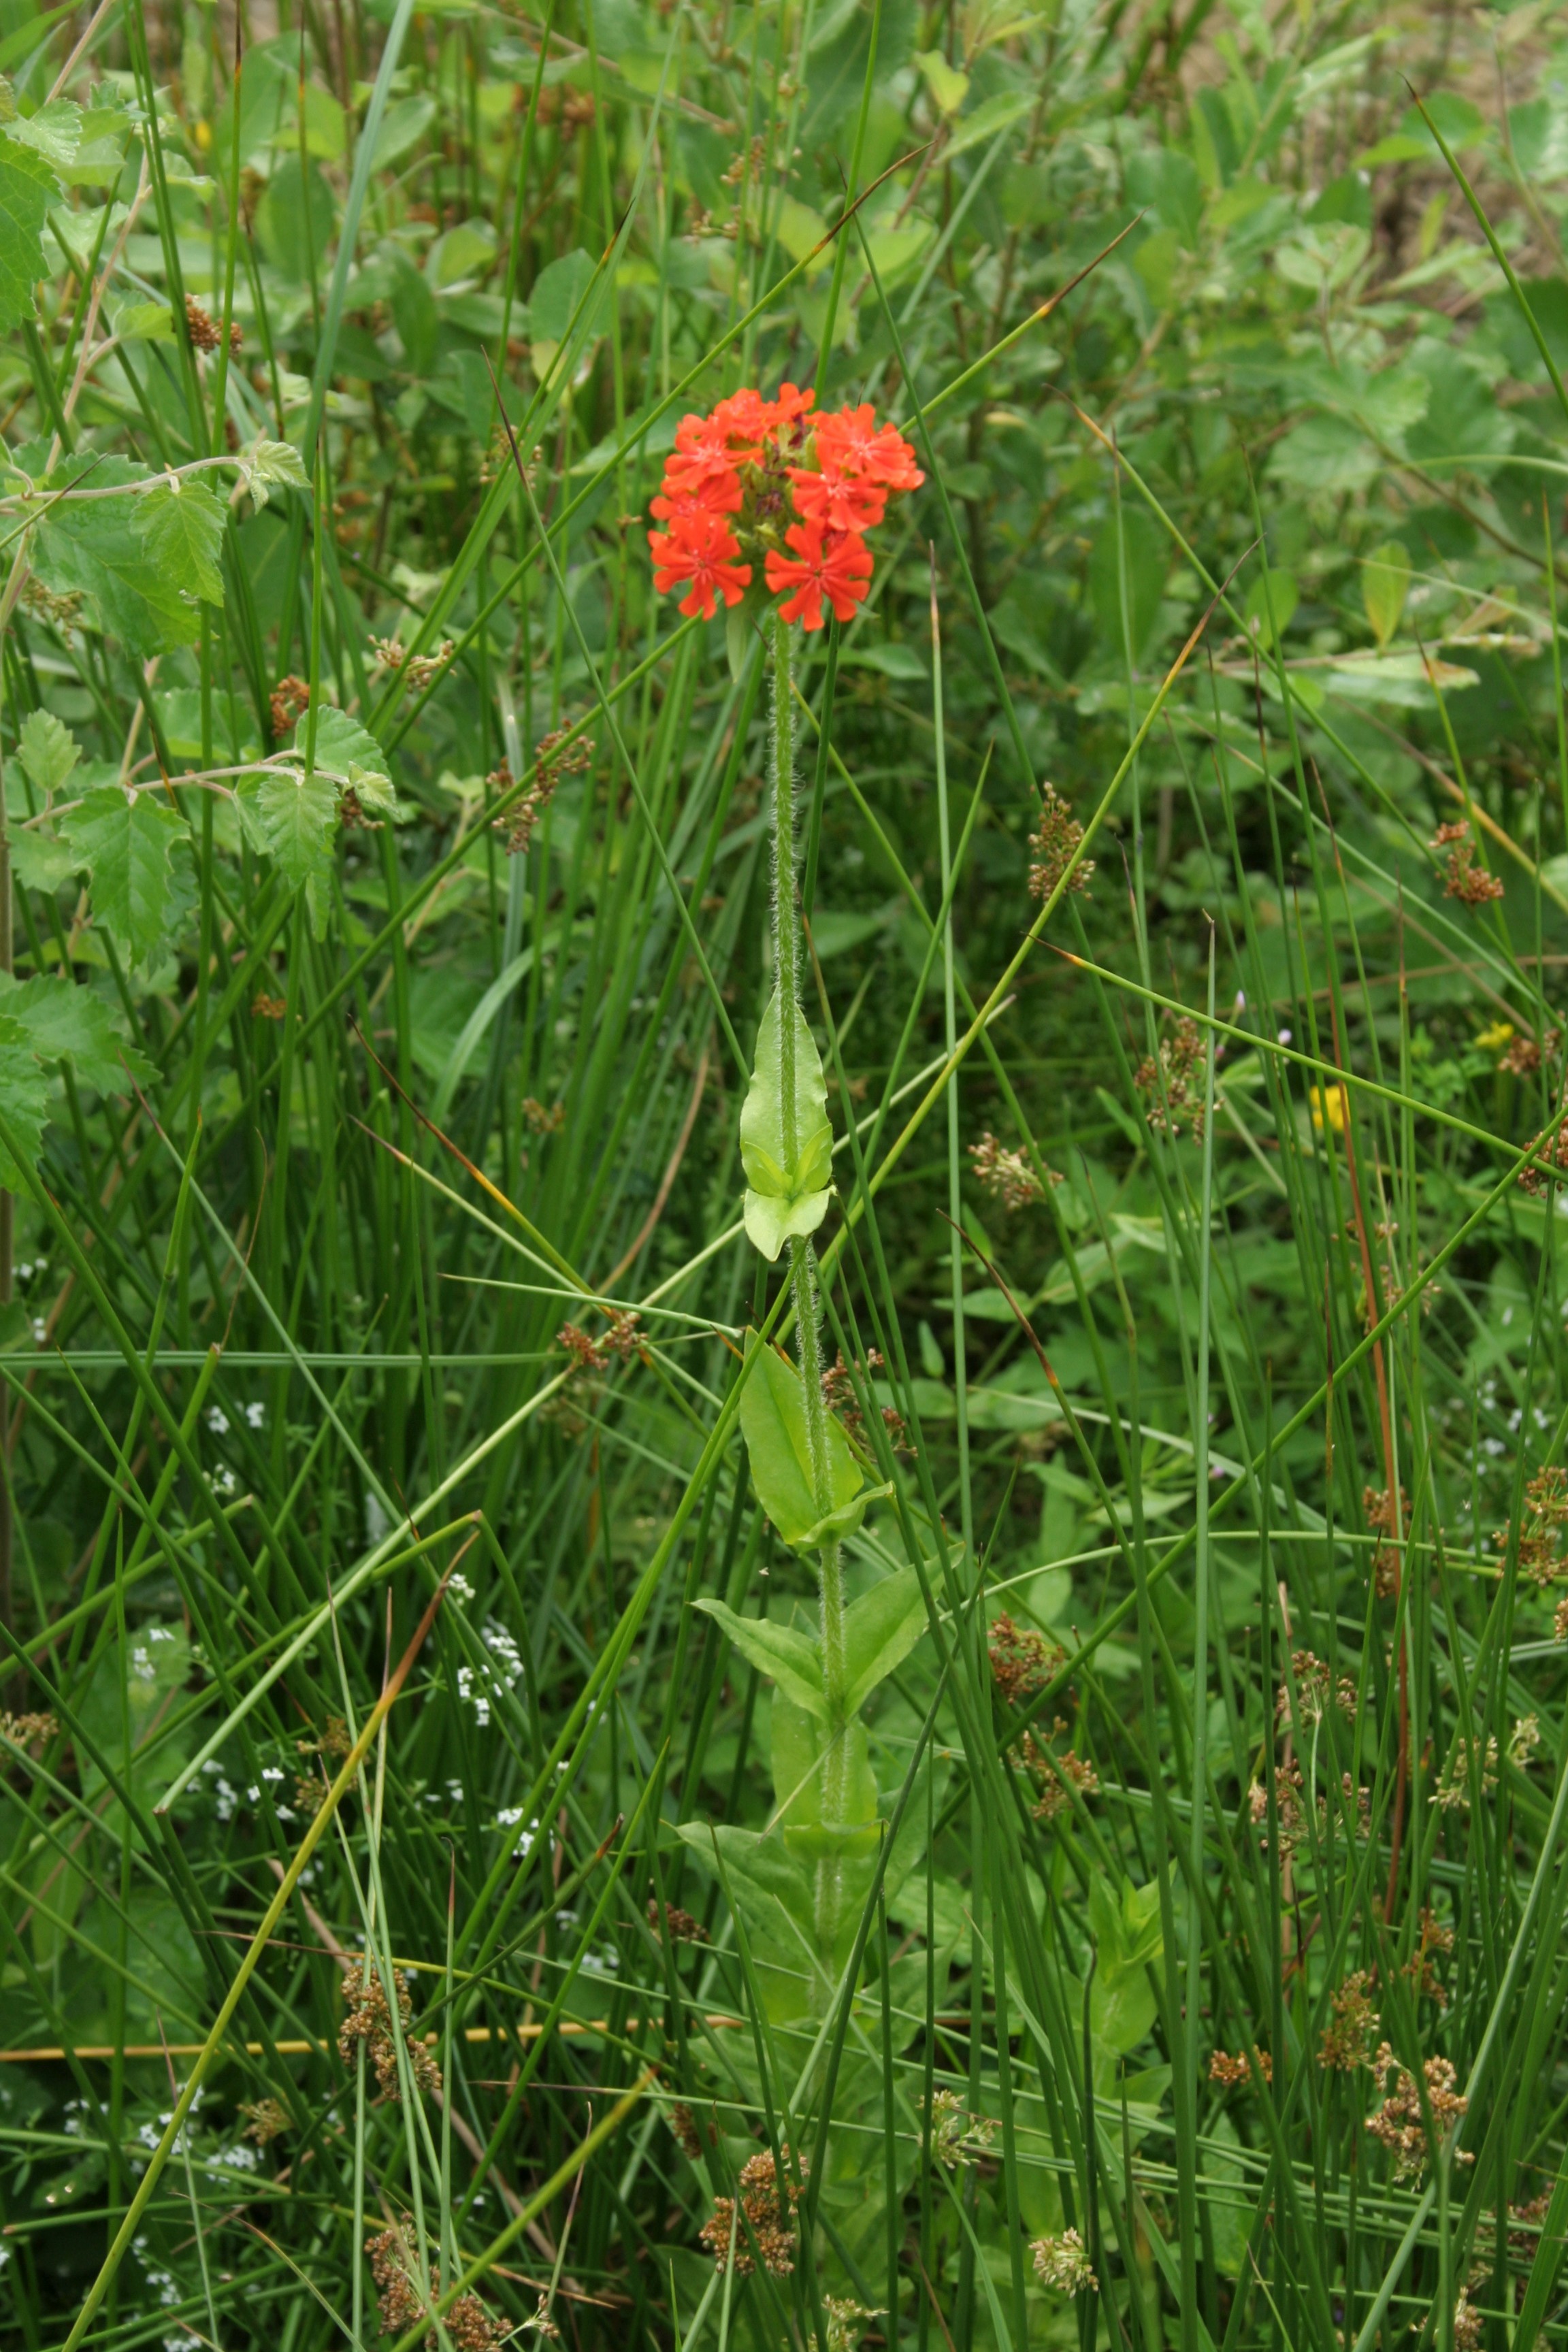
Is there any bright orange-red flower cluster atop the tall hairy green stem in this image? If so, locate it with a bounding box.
[649,383,926,628]
